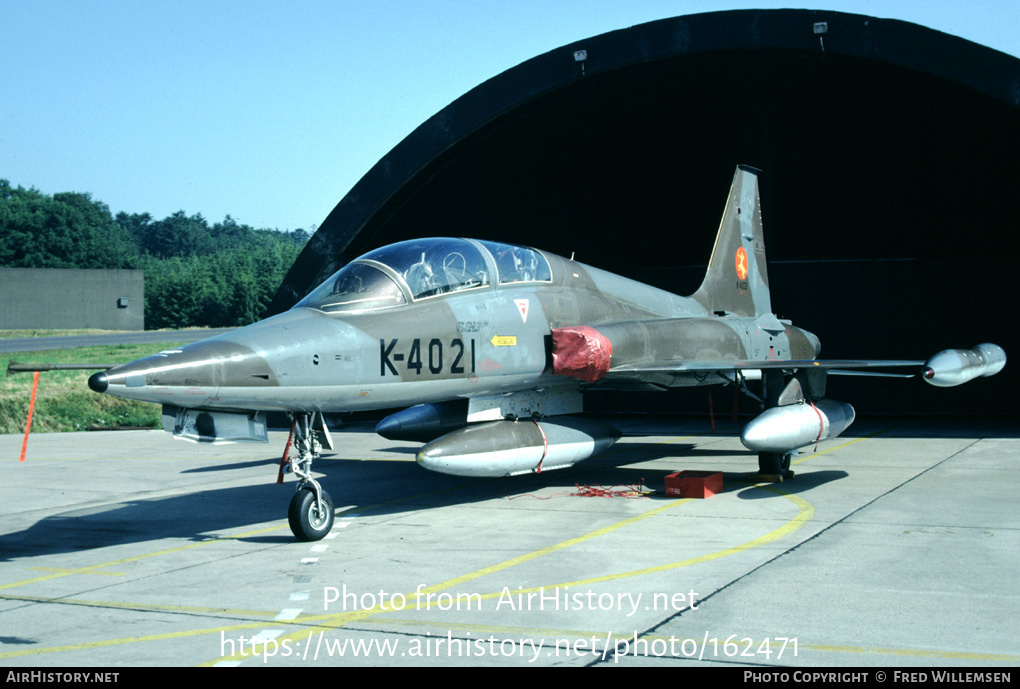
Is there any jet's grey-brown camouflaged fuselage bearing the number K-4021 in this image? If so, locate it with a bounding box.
[87,248,816,412]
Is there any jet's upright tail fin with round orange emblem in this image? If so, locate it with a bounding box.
[691,165,772,316]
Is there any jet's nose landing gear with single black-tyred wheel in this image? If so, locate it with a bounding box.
[284,412,335,541]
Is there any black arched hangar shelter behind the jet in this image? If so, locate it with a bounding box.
[273,10,1020,413]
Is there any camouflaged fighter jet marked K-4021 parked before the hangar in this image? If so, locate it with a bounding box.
[89,165,1006,540]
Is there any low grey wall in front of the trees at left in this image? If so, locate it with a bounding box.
[0,268,145,330]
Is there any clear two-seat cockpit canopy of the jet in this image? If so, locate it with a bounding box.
[297,238,552,312]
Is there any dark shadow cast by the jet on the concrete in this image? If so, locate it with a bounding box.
[0,442,846,561]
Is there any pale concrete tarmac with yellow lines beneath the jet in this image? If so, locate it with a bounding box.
[0,419,1020,668]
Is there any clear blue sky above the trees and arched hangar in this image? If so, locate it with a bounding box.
[0,0,1020,230]
